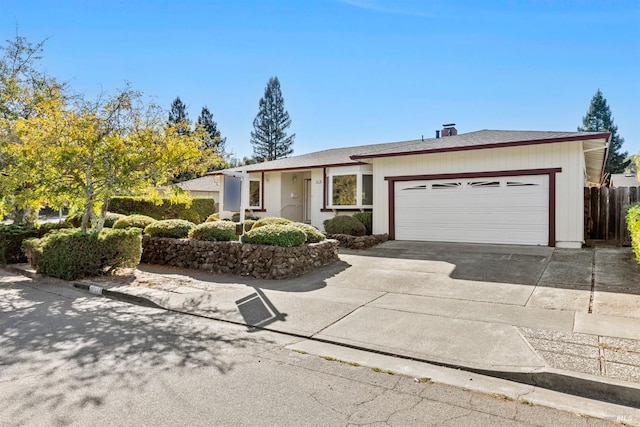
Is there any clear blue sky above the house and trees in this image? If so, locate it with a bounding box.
[0,0,640,158]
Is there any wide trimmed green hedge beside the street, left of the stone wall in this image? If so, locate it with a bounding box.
[23,228,142,280]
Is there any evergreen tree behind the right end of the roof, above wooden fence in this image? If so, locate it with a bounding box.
[578,89,631,176]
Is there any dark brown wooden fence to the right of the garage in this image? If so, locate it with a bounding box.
[584,187,640,245]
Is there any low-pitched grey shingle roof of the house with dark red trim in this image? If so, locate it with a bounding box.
[209,130,611,181]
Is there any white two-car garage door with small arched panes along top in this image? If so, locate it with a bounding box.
[395,175,549,245]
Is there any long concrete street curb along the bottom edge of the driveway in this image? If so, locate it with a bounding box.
[73,283,640,409]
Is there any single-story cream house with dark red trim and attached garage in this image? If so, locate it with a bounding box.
[215,124,611,248]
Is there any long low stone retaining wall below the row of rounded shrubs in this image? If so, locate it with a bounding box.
[141,236,338,279]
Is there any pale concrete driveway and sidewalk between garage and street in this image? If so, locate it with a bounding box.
[5,241,640,408]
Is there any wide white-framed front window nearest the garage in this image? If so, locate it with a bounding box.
[327,172,373,208]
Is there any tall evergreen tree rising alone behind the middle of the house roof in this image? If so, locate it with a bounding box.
[251,77,296,161]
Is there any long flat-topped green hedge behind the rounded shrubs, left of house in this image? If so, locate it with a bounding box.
[109,196,215,224]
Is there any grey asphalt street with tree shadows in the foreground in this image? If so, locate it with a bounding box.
[0,270,625,426]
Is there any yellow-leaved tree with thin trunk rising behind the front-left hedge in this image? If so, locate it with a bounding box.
[14,86,219,230]
